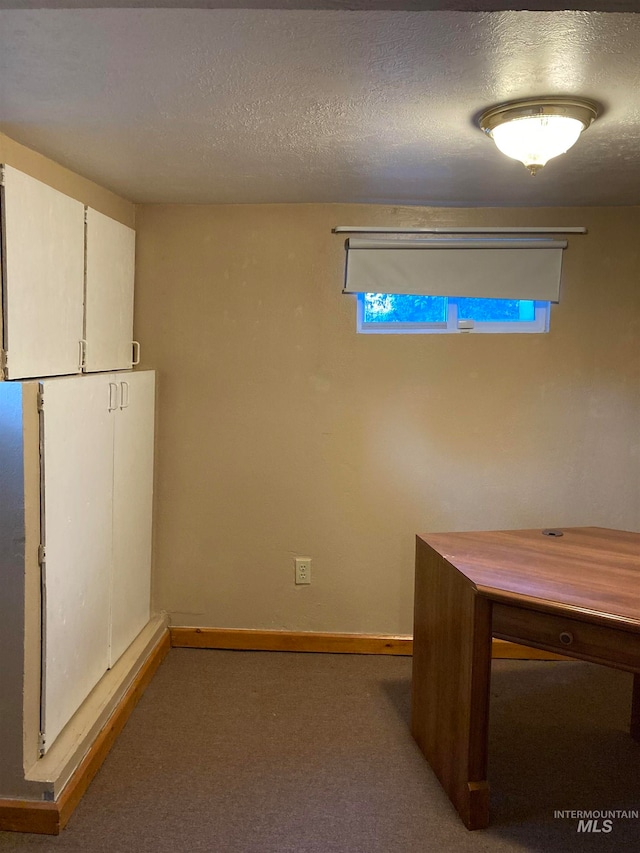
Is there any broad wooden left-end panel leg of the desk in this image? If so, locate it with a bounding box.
[411,539,491,829]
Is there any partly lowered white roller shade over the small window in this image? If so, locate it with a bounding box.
[344,239,567,302]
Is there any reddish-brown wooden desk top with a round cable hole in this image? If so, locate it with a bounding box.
[419,527,640,632]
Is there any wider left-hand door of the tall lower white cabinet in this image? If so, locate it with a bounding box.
[41,376,115,749]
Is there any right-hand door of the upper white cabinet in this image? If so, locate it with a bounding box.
[84,208,135,372]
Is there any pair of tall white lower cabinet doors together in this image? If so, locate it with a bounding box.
[40,371,155,750]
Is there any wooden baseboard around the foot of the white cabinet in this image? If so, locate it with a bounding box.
[0,631,171,835]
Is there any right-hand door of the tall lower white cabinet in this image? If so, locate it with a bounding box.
[110,370,155,664]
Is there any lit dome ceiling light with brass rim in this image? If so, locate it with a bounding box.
[478,97,598,175]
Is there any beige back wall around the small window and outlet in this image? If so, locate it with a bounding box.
[136,205,640,633]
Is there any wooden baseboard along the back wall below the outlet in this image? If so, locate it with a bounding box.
[169,628,567,660]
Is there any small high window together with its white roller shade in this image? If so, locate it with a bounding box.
[342,237,567,334]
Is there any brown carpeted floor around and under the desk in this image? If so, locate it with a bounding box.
[0,649,640,853]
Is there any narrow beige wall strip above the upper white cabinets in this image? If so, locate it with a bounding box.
[0,133,135,228]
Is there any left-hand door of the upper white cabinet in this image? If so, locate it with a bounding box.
[2,166,84,379]
